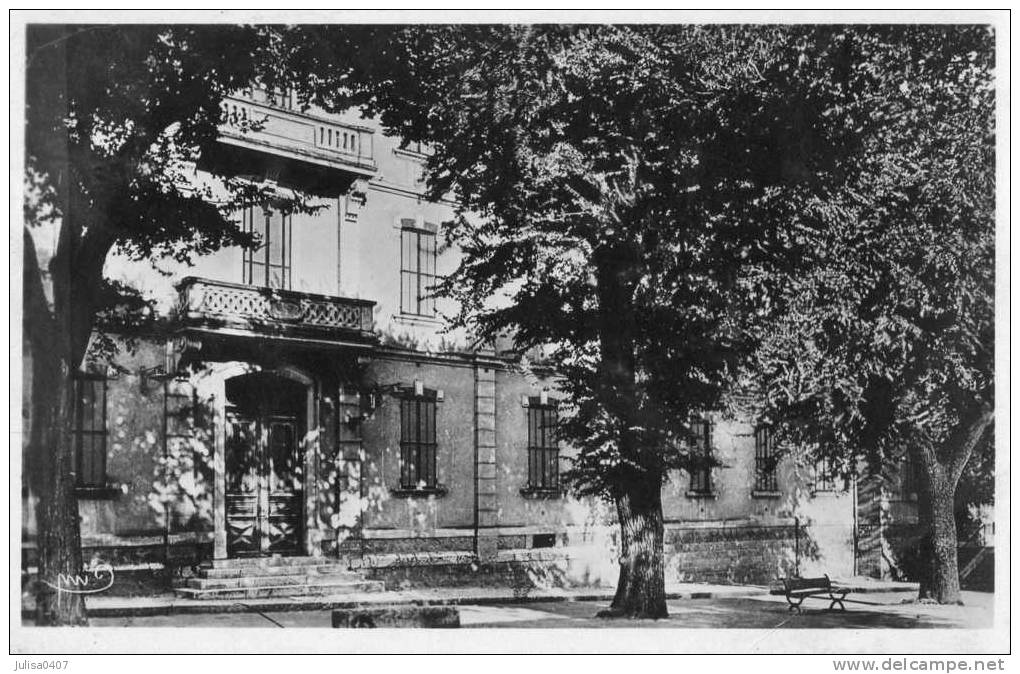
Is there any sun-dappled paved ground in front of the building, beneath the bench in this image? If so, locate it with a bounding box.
[91,592,993,629]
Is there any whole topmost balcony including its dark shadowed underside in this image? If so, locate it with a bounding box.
[204,95,376,195]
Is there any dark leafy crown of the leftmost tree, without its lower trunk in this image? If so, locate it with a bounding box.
[26,25,318,352]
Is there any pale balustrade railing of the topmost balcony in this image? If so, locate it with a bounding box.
[220,92,375,175]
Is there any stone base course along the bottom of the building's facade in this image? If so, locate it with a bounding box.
[24,523,816,593]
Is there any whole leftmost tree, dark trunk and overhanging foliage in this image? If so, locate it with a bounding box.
[23,24,304,625]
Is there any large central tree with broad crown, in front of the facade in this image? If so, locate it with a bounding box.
[277,25,885,618]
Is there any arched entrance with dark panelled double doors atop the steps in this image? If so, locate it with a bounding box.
[224,372,307,557]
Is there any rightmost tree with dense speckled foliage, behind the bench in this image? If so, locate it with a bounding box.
[754,27,995,603]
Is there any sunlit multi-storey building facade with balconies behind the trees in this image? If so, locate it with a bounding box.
[22,92,909,583]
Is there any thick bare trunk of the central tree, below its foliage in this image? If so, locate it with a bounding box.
[603,475,667,618]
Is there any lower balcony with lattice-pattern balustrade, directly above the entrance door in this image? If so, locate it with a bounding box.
[176,276,376,347]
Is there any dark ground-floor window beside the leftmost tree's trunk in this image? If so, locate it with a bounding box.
[71,374,107,489]
